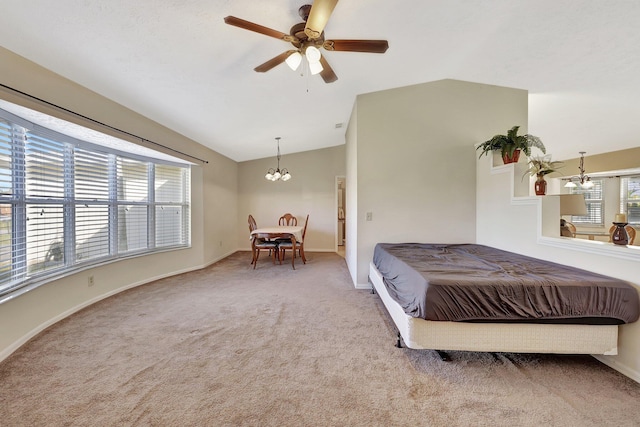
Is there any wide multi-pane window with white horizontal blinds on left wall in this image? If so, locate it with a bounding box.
[0,109,190,295]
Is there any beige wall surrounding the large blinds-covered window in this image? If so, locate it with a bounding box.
[0,48,237,360]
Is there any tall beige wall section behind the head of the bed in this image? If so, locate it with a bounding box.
[347,80,527,287]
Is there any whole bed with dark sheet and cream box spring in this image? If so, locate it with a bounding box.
[369,243,640,355]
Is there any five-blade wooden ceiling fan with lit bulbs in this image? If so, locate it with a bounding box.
[224,0,389,83]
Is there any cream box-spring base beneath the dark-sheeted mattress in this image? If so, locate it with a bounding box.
[369,263,618,355]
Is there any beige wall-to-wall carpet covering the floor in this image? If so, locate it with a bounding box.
[0,252,640,426]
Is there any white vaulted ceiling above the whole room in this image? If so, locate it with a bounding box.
[0,0,640,161]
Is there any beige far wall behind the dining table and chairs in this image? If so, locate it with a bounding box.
[236,145,350,252]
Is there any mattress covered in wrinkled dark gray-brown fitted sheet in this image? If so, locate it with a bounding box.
[373,243,640,324]
